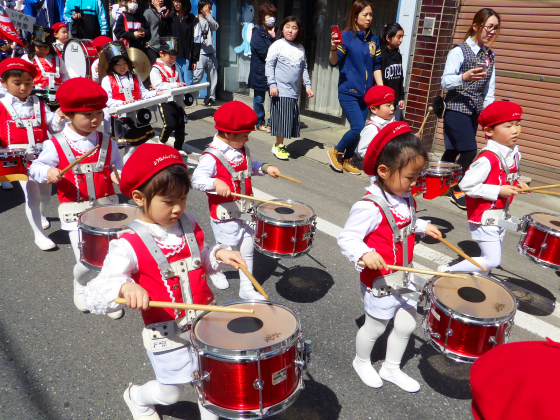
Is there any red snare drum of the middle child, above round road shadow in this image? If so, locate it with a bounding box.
[253,199,317,258]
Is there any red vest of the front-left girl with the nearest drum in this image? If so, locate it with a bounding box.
[121,224,214,325]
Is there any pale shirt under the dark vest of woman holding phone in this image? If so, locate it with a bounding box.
[441,37,496,108]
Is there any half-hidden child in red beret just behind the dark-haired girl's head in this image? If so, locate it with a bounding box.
[356,85,395,162]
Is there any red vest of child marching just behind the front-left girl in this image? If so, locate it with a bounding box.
[51,133,115,204]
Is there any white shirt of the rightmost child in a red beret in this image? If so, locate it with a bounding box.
[459,140,521,201]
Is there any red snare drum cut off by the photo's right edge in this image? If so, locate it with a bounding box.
[517,213,560,270]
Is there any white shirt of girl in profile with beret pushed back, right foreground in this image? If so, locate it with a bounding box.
[337,184,430,271]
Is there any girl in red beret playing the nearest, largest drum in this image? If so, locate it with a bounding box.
[85,143,246,420]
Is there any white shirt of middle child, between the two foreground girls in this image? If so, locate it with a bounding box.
[191,135,264,191]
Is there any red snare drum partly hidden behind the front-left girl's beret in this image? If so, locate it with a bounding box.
[78,204,142,271]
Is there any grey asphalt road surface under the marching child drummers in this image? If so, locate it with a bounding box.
[0,115,560,420]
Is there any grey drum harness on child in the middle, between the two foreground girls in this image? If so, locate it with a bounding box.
[203,145,253,222]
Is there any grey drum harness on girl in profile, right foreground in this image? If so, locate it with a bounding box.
[362,194,424,301]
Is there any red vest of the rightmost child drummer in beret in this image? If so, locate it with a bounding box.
[465,151,518,224]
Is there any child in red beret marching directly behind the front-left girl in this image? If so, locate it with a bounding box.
[29,77,122,319]
